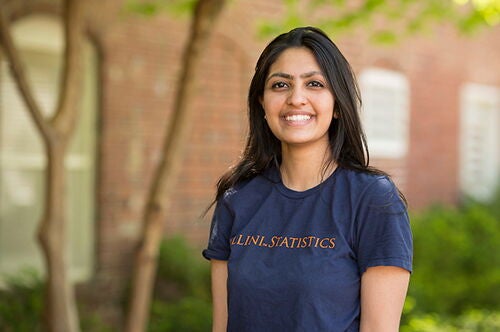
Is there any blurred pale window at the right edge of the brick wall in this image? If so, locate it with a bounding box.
[459,84,500,201]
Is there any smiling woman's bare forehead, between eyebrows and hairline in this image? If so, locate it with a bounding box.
[268,47,320,76]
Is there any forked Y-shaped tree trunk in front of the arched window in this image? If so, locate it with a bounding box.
[0,0,83,332]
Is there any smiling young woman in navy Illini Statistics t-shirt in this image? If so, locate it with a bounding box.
[203,27,412,332]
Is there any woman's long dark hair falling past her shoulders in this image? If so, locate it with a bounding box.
[215,27,400,200]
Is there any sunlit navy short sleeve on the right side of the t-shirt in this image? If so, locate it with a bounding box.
[356,177,413,274]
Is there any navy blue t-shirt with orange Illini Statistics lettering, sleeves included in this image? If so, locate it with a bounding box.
[203,167,412,332]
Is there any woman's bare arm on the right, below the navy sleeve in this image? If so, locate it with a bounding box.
[360,266,410,332]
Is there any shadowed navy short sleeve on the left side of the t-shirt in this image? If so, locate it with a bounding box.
[202,199,233,260]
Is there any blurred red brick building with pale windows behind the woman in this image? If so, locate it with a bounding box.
[0,0,500,322]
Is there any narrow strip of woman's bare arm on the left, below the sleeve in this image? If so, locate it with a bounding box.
[210,259,227,332]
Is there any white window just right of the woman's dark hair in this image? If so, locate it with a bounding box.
[360,68,409,158]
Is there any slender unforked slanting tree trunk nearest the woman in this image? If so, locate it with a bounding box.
[125,0,225,332]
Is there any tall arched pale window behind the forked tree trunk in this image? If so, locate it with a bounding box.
[0,16,96,280]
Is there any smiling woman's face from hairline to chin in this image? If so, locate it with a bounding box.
[261,47,334,149]
